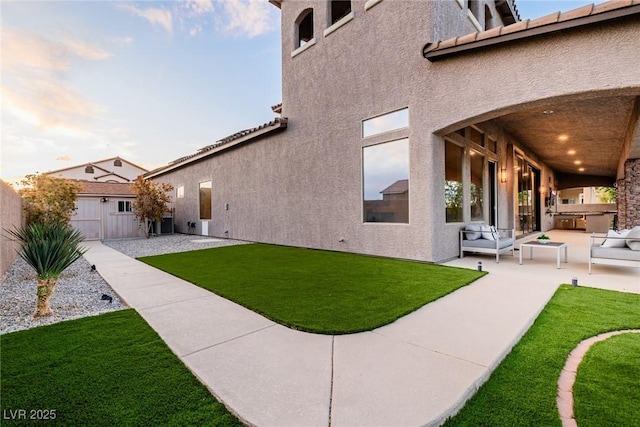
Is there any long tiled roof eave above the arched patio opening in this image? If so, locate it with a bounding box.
[422,4,640,62]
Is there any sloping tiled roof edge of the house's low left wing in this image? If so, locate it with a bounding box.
[144,117,288,178]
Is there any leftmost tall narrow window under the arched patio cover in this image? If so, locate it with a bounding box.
[444,141,464,222]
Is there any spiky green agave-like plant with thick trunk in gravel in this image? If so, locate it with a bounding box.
[6,223,87,318]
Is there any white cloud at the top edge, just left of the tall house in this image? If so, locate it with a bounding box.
[222,0,277,37]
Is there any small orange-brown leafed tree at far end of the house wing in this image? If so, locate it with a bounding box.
[131,176,173,238]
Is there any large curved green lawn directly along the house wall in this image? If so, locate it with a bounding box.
[140,244,486,334]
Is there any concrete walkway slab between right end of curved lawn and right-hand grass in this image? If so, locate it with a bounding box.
[376,276,557,367]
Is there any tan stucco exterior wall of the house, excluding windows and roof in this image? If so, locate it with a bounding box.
[155,0,640,262]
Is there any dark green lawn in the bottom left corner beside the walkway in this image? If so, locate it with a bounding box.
[0,310,242,426]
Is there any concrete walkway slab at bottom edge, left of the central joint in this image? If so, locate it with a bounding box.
[183,325,333,427]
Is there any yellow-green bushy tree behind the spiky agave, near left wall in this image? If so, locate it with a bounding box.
[18,174,82,224]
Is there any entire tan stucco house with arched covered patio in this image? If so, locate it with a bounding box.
[145,0,640,262]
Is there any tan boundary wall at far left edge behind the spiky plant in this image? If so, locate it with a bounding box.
[0,180,24,278]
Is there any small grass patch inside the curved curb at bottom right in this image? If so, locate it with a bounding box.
[573,334,640,427]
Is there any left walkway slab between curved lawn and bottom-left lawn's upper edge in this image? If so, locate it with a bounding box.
[139,292,275,356]
